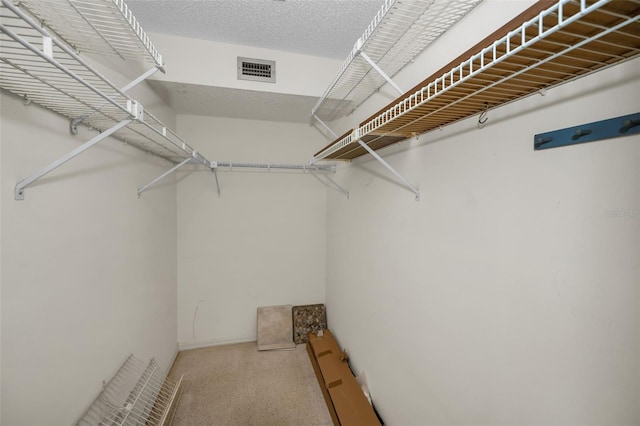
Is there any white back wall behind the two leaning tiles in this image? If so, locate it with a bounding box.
[178,115,327,348]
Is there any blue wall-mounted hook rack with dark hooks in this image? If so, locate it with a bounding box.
[533,112,640,151]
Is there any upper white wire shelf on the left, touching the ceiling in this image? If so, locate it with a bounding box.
[20,0,164,67]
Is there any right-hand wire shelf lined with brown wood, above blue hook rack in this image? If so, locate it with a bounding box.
[311,0,640,163]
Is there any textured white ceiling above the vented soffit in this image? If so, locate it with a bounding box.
[127,0,384,59]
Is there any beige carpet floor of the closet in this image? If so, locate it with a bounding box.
[169,342,333,426]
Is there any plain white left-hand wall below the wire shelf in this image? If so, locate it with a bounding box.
[0,82,177,425]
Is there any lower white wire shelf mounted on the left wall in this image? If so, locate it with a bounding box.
[0,0,208,164]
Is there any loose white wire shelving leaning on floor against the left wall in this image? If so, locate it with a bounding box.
[76,355,182,426]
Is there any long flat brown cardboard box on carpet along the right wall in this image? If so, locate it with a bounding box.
[307,330,380,426]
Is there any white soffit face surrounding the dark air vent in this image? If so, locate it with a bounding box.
[152,33,341,96]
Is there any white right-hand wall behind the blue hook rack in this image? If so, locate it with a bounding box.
[326,2,640,425]
